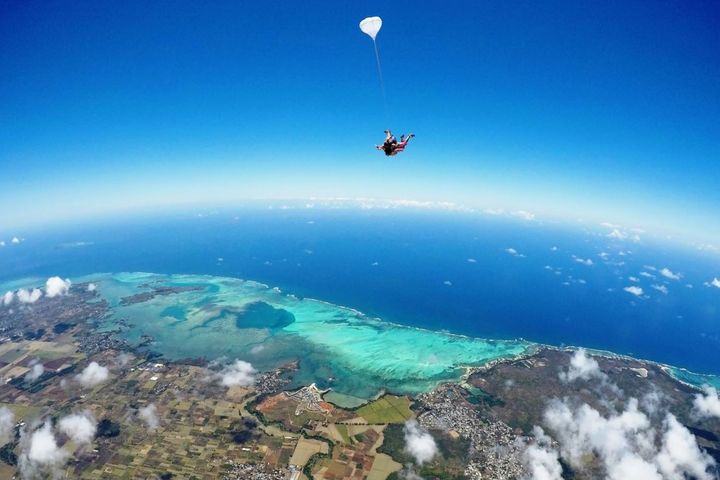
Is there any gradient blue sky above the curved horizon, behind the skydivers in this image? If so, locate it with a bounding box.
[0,0,720,241]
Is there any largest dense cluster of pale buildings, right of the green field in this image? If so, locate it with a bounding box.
[418,384,525,480]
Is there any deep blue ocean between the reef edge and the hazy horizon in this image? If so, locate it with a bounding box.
[0,208,720,374]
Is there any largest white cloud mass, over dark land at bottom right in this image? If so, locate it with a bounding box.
[544,398,714,480]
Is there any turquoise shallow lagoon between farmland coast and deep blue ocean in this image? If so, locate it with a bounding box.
[88,273,535,404]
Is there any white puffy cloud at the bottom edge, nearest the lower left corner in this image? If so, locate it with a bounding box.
[18,420,68,479]
